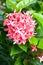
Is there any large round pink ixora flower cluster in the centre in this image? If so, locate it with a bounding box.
[4,12,36,44]
